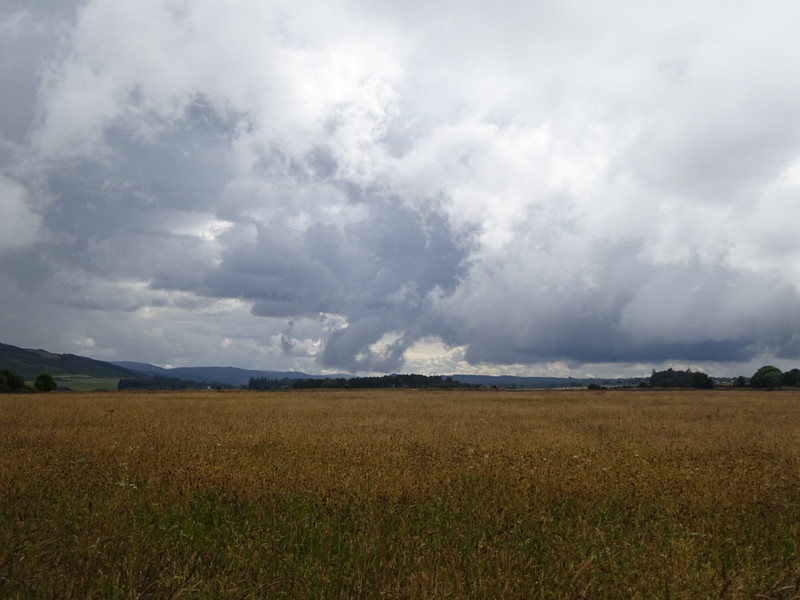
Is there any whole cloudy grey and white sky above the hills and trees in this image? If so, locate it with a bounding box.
[0,0,800,377]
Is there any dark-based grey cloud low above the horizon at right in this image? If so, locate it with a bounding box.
[441,246,800,364]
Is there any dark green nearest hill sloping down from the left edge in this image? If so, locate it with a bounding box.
[0,344,138,380]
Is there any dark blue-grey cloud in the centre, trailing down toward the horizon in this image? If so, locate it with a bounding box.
[165,198,466,372]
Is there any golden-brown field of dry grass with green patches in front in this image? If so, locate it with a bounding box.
[0,390,800,599]
